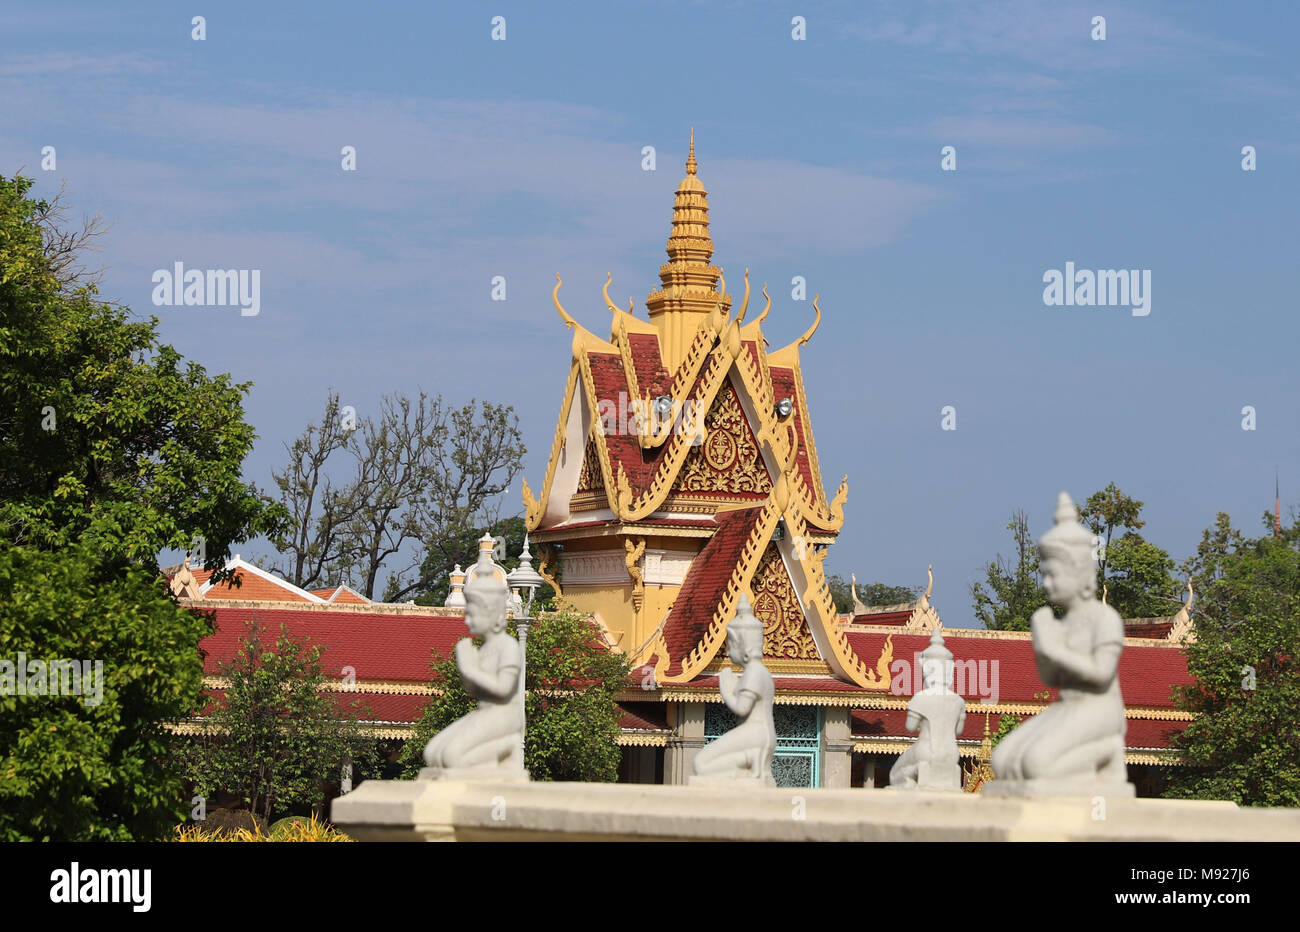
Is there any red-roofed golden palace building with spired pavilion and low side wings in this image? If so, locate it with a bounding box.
[172,138,1192,796]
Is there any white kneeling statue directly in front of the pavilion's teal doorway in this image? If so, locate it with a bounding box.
[689,593,776,786]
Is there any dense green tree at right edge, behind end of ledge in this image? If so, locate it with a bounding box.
[1165,512,1300,806]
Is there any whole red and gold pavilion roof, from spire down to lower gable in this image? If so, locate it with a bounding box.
[523,142,863,685]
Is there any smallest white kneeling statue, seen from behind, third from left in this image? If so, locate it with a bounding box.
[889,629,966,790]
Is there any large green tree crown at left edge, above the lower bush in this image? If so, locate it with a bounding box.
[0,170,285,569]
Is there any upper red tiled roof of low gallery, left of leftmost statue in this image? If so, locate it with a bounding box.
[199,606,469,684]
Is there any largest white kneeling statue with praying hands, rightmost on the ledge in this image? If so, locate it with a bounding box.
[982,493,1134,797]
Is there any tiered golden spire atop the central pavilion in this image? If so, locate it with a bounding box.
[646,129,731,372]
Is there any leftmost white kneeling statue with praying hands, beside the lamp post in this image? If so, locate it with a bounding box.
[420,550,528,780]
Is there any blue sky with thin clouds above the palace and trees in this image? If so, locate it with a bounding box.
[0,0,1300,625]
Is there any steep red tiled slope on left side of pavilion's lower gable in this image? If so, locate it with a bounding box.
[663,507,763,676]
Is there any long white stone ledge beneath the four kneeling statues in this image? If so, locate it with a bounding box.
[332,780,1300,841]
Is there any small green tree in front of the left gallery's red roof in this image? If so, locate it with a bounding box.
[181,623,373,822]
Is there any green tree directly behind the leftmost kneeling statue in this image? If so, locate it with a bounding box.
[402,606,631,783]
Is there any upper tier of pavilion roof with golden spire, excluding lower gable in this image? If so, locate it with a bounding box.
[524,144,848,539]
